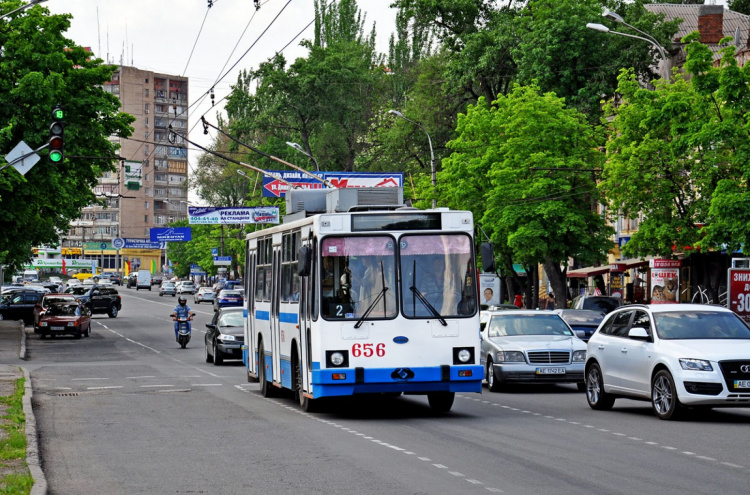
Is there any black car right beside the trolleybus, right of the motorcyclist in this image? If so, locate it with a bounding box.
[204,308,245,365]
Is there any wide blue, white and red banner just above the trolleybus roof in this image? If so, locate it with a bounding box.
[263,170,404,198]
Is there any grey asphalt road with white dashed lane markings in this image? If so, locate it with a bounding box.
[23,288,750,495]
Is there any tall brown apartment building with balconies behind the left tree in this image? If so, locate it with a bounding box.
[63,66,188,271]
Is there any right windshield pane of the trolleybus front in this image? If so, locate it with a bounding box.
[399,234,477,318]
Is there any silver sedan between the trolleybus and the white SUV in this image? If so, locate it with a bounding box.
[480,310,586,392]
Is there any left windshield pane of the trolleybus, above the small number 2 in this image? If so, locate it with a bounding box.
[320,235,398,320]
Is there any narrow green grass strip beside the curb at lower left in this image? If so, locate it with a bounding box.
[0,378,34,495]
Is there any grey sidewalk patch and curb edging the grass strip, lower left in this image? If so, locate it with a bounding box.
[0,320,47,495]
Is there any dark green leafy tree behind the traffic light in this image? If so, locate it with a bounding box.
[0,0,134,274]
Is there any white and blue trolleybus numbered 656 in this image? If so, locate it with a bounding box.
[243,188,483,412]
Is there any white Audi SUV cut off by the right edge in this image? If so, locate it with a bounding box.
[585,304,750,419]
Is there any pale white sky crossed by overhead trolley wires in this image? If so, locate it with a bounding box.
[42,0,396,188]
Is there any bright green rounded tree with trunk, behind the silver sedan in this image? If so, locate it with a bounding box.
[440,85,612,303]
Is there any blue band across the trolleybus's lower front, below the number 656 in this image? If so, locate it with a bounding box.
[312,363,484,399]
